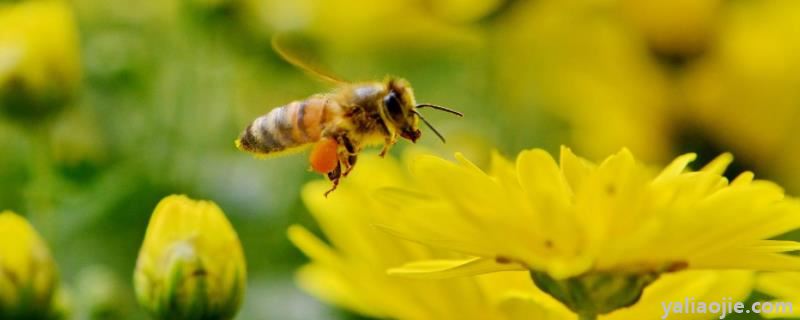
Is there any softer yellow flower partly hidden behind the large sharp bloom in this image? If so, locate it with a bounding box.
[289,156,753,320]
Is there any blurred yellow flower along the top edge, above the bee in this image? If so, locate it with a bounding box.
[232,0,482,53]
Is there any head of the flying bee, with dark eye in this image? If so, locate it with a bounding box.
[381,79,422,142]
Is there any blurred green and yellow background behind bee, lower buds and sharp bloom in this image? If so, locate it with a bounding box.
[0,0,800,319]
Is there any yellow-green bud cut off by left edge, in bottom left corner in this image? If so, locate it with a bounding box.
[0,211,58,319]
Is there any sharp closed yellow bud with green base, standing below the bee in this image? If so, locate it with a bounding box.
[134,195,247,320]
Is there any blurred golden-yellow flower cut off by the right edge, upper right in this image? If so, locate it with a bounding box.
[678,0,800,194]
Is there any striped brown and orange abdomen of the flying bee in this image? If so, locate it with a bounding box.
[237,97,339,154]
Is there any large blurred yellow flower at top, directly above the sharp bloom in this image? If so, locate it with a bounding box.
[496,0,672,160]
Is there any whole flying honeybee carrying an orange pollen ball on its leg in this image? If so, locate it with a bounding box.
[236,38,463,196]
